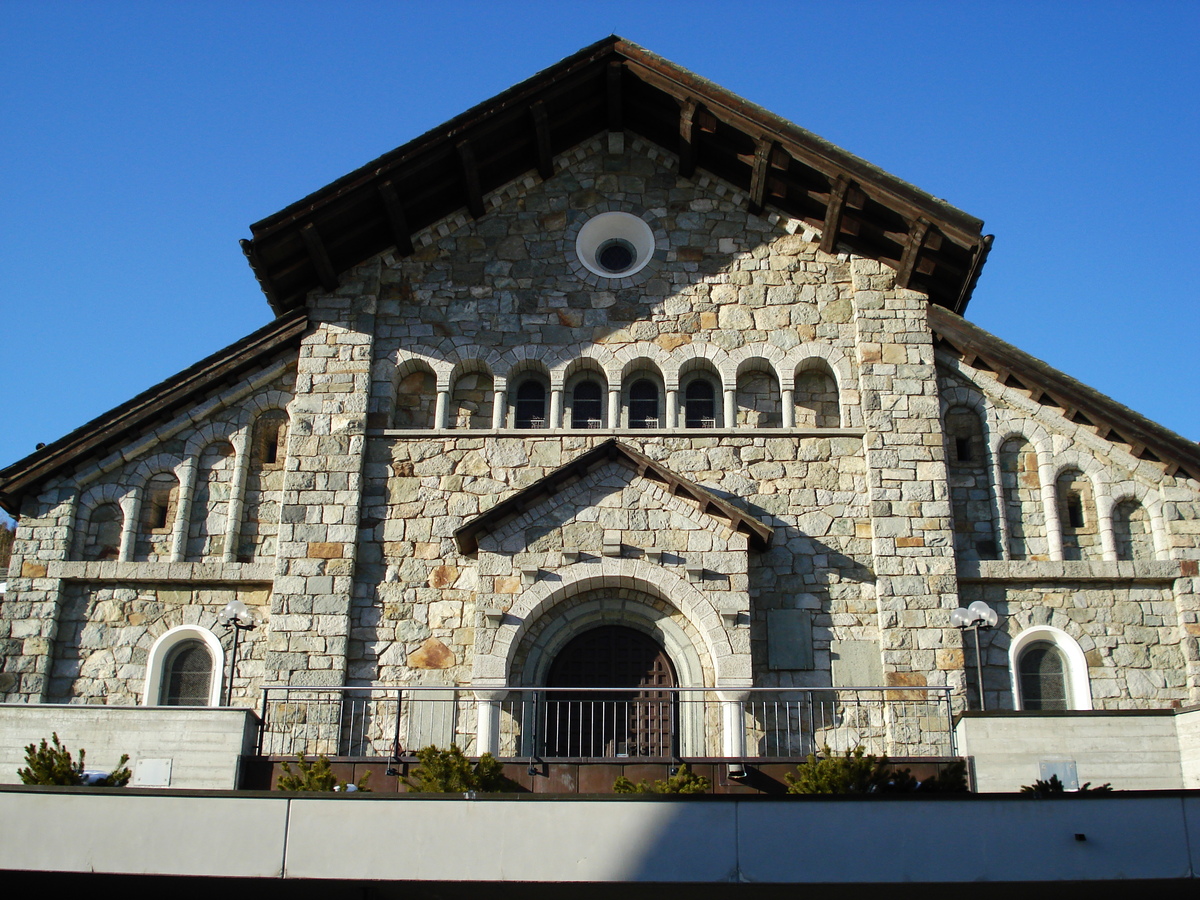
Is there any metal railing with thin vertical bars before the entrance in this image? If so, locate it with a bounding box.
[258,686,956,760]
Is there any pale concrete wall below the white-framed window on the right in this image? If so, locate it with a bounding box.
[955,710,1185,793]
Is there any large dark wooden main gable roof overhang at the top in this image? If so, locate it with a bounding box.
[242,36,991,313]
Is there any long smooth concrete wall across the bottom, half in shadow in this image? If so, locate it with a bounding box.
[0,787,1200,884]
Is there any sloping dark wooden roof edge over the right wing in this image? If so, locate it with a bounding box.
[929,306,1200,480]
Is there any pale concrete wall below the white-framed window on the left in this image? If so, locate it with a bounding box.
[0,703,257,790]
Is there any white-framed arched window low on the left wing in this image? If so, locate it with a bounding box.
[142,625,224,707]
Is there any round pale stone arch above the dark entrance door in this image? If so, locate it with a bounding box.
[472,557,751,688]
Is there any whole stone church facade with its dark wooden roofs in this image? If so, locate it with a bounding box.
[0,38,1200,768]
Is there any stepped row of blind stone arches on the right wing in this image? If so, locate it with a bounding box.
[943,403,1164,560]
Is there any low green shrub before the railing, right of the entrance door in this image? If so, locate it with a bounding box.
[784,745,967,793]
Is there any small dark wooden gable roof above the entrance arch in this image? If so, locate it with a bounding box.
[454,438,774,554]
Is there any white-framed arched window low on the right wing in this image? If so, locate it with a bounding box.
[1009,625,1092,709]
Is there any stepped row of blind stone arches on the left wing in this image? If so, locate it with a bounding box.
[71,407,288,563]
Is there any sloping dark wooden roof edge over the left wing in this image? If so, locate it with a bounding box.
[0,310,308,516]
